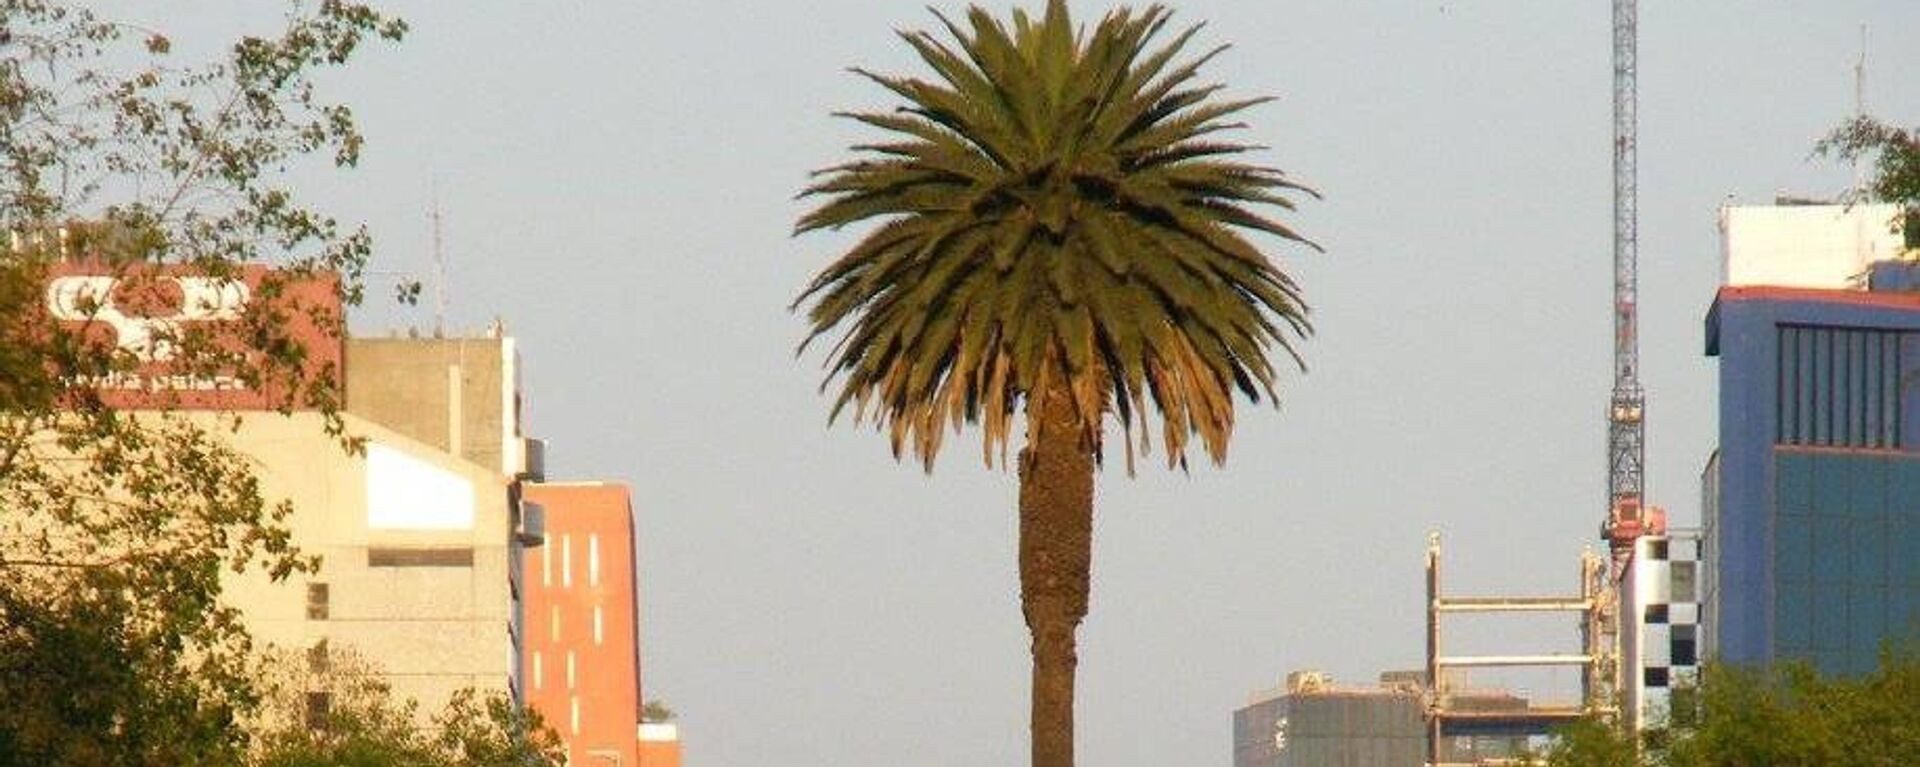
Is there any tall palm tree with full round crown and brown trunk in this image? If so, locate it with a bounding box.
[795,0,1313,767]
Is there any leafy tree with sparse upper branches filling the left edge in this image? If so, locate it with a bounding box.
[0,0,405,765]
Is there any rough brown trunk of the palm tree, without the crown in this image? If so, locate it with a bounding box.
[1020,384,1092,767]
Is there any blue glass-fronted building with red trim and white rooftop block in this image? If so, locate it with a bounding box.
[1699,206,1920,675]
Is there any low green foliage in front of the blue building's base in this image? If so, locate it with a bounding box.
[1546,650,1920,767]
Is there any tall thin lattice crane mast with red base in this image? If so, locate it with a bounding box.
[1601,0,1647,581]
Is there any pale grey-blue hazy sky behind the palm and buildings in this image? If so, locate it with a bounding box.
[123,0,1920,767]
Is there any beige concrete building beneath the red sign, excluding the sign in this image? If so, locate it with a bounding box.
[227,331,540,709]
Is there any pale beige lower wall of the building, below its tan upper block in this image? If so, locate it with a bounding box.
[216,413,515,709]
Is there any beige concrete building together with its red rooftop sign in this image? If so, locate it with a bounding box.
[33,260,541,711]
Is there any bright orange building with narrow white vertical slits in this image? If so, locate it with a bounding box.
[520,482,678,767]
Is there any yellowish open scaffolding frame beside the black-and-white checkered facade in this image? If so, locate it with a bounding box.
[1425,532,1619,767]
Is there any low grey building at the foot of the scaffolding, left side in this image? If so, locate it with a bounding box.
[1233,671,1526,767]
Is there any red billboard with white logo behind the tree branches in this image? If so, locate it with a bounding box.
[42,263,346,409]
